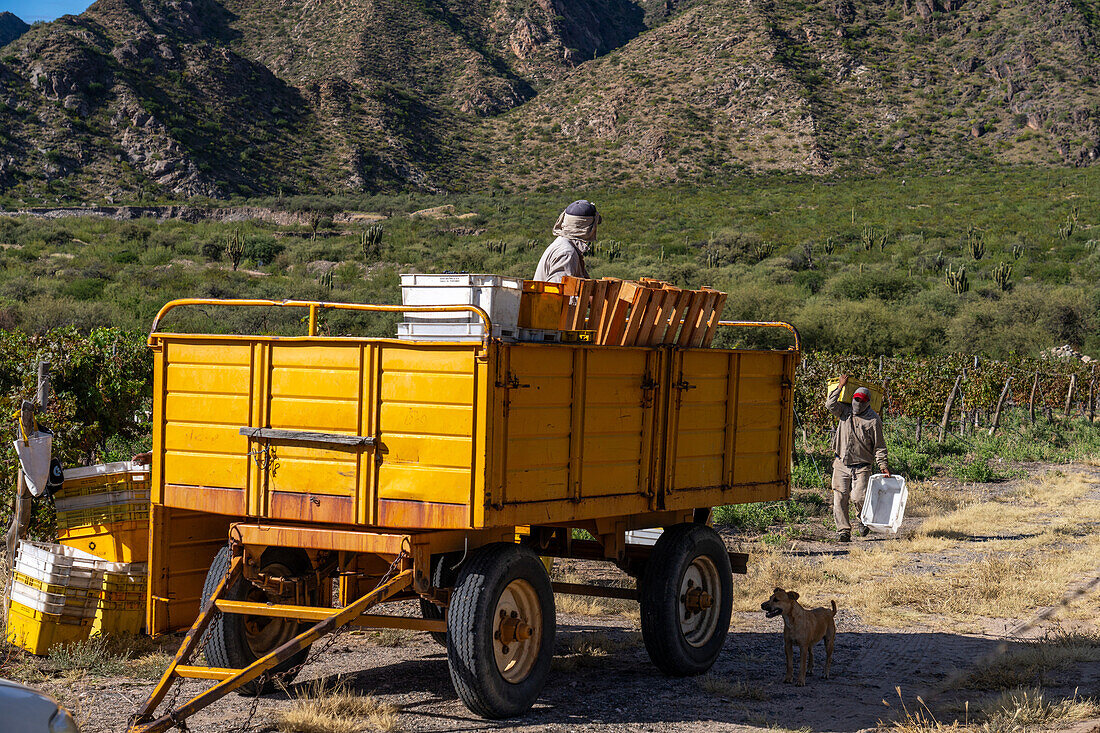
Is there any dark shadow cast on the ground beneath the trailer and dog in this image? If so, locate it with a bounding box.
[290,625,1012,733]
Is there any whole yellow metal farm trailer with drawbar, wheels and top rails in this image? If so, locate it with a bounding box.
[130,299,800,733]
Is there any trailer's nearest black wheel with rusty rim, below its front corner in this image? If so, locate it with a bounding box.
[447,543,557,719]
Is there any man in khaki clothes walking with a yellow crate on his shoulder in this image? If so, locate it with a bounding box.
[825,374,890,543]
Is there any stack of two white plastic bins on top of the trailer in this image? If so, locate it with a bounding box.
[397,274,524,341]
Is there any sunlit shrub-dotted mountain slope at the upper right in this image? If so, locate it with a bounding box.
[475,0,1100,185]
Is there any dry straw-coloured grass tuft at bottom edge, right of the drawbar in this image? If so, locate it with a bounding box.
[275,683,398,733]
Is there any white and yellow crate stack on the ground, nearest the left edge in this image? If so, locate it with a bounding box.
[7,540,103,655]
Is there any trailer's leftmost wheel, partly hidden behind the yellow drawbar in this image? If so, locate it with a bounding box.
[202,546,317,694]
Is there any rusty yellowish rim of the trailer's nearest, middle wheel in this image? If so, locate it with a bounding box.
[493,579,542,685]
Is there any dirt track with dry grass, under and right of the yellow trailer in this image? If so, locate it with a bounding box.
[25,466,1100,733]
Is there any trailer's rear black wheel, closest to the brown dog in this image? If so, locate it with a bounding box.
[640,524,734,677]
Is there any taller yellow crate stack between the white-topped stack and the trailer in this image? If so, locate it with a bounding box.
[54,461,150,562]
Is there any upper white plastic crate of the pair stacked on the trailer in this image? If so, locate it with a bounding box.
[402,274,524,335]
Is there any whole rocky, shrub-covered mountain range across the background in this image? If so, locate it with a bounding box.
[0,0,1100,199]
